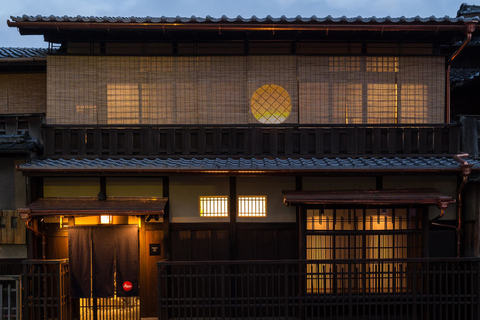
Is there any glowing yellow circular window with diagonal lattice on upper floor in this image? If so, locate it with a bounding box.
[250,84,292,124]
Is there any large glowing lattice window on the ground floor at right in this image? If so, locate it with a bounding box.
[306,208,421,292]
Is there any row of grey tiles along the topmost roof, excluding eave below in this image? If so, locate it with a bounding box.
[10,15,478,23]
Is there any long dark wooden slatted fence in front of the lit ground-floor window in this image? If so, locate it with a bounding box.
[158,258,480,320]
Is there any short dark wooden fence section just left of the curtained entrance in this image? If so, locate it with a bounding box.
[23,259,71,320]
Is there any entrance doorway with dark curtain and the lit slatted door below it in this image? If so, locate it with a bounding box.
[68,225,140,320]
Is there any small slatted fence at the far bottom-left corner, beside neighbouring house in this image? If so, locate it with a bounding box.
[0,275,22,320]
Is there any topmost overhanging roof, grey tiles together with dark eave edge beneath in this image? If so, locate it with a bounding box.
[7,15,478,34]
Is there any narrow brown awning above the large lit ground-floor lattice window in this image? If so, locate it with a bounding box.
[283,189,455,208]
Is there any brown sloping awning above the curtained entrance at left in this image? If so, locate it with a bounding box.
[21,198,168,216]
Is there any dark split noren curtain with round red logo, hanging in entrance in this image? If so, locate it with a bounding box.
[68,225,138,298]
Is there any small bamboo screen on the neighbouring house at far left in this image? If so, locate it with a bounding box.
[0,73,47,114]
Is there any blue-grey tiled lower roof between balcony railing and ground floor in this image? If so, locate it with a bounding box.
[15,157,480,172]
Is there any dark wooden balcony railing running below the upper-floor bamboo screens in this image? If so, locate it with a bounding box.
[44,124,461,158]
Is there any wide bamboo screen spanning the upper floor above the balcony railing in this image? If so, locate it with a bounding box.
[47,55,445,125]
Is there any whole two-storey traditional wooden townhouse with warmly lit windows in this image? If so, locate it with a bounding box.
[0,3,480,319]
